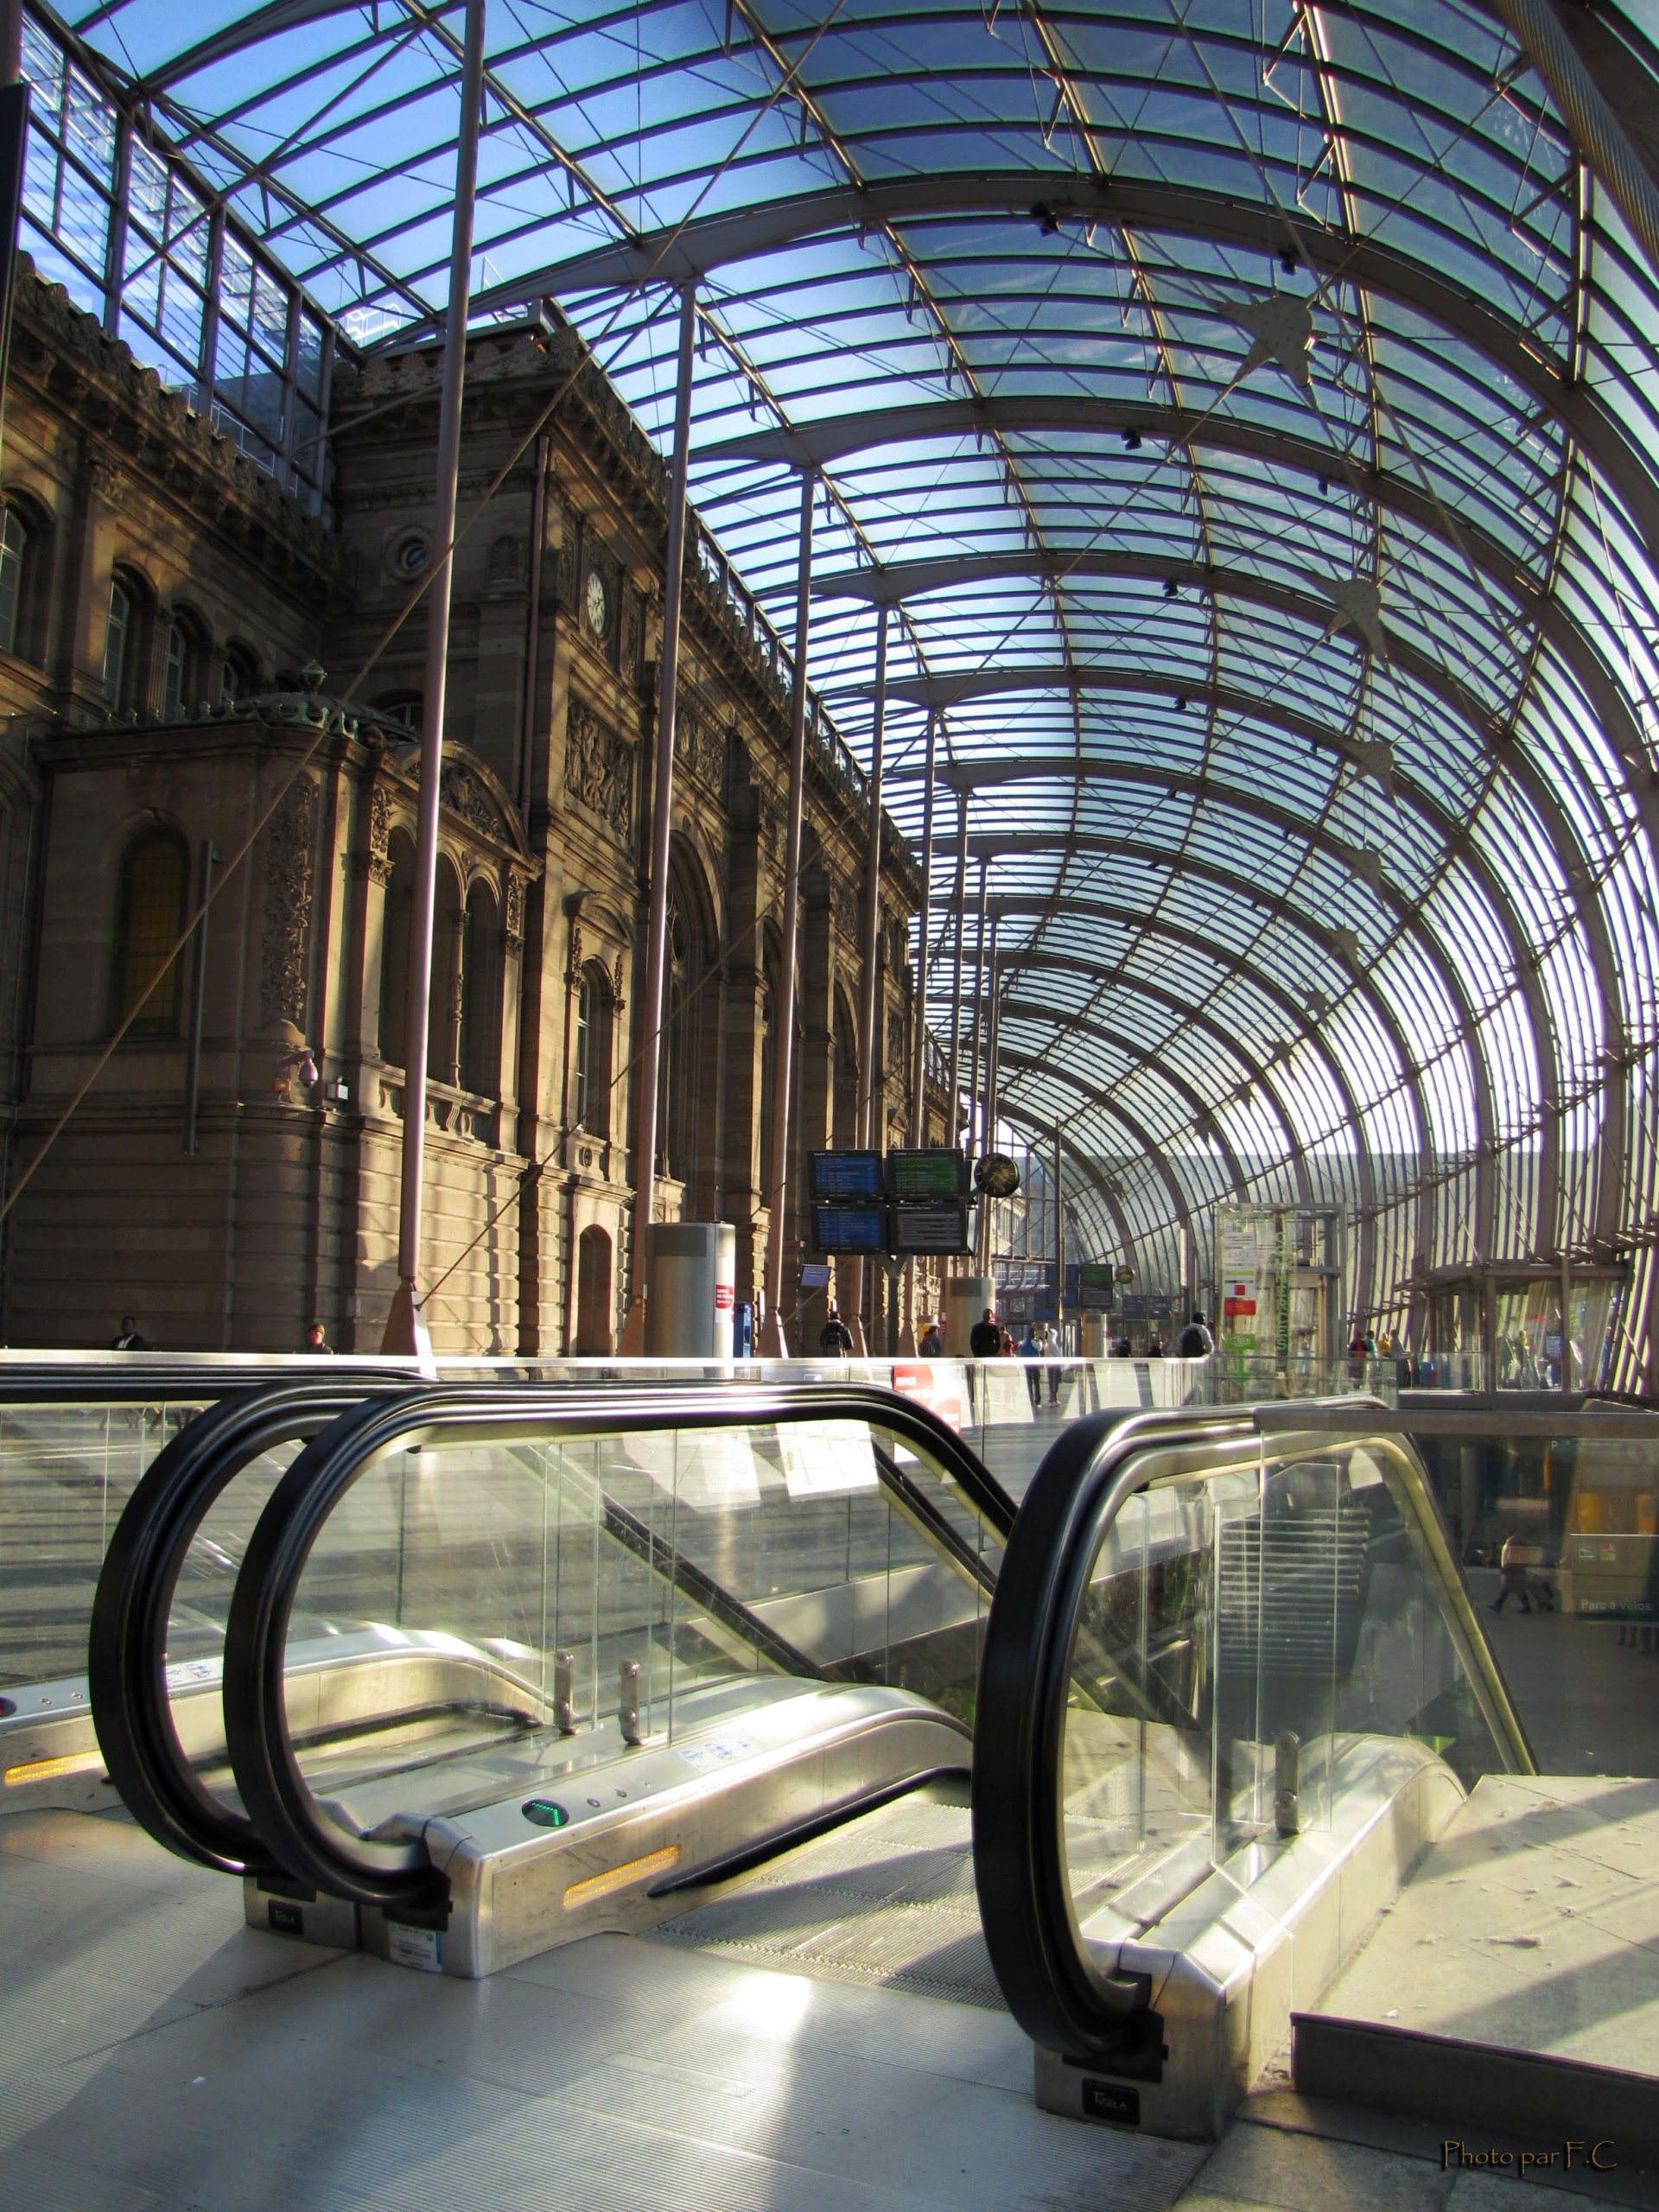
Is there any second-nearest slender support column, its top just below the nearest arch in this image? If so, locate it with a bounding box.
[621,283,696,1358]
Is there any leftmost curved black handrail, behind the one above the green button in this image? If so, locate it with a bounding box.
[86,1371,407,1873]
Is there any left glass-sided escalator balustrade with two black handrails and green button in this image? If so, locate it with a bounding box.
[93,1387,1013,1975]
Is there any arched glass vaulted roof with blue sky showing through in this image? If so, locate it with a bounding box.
[29,0,1659,1344]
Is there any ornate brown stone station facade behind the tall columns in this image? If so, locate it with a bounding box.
[0,274,943,1356]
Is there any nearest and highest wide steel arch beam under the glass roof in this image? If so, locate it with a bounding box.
[474,170,1659,544]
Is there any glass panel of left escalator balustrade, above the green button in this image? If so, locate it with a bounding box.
[285,1421,1000,1825]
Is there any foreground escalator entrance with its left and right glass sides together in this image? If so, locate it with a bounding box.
[48,1385,1533,2139]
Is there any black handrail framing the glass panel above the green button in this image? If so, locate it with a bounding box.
[224,1385,1015,1911]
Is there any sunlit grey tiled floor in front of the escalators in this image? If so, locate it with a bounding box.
[0,1814,1637,2212]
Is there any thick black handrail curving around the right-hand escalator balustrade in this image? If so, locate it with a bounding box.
[971,1411,1255,2063]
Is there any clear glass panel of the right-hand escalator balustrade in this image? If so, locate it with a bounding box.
[1062,1438,1510,1920]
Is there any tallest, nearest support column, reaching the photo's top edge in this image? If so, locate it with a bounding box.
[380,0,485,1360]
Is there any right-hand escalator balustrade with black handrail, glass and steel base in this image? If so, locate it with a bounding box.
[973,1402,1533,2139]
